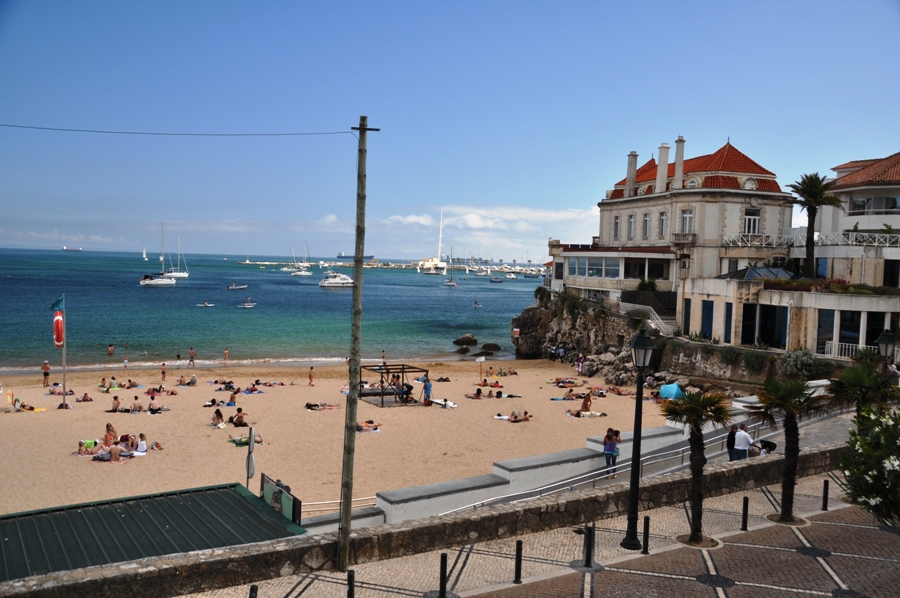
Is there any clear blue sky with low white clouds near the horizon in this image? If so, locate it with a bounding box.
[0,0,900,261]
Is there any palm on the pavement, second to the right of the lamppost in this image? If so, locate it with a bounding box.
[747,378,830,523]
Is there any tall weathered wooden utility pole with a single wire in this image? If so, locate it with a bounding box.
[337,116,381,571]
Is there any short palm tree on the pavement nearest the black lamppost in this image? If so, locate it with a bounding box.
[662,392,731,545]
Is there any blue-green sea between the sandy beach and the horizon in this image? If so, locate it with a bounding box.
[0,248,541,374]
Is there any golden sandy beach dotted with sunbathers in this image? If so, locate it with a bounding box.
[0,361,663,514]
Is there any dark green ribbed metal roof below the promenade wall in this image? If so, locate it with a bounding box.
[0,484,305,581]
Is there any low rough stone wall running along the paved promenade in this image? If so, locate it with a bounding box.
[0,444,846,598]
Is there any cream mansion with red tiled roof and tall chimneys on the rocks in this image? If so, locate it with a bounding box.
[550,137,792,342]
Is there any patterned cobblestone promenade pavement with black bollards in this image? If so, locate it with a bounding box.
[185,472,900,598]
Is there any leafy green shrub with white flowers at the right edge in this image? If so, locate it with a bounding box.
[840,408,900,529]
